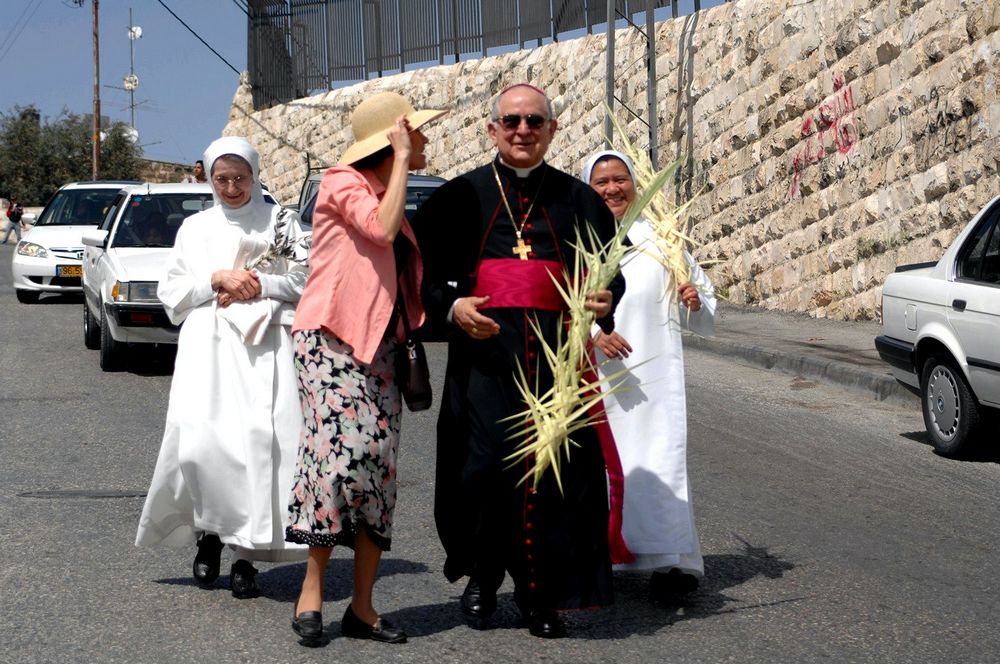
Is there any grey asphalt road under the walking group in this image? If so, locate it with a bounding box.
[0,247,1000,664]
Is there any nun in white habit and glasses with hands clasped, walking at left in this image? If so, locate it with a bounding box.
[136,137,307,598]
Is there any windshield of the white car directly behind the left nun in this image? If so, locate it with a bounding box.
[108,193,214,247]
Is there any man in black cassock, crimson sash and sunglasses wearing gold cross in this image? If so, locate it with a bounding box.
[414,83,624,638]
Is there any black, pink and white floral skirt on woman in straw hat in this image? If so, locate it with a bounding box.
[285,330,401,551]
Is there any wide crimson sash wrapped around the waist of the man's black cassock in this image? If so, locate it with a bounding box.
[472,258,566,311]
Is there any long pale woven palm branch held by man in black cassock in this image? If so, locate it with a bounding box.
[505,163,673,491]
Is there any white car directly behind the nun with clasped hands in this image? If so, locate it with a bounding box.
[83,184,213,371]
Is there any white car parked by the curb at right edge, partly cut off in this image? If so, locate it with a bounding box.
[875,196,1000,456]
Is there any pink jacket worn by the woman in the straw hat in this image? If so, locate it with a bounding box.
[292,166,424,364]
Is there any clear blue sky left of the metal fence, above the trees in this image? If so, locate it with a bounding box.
[0,0,247,164]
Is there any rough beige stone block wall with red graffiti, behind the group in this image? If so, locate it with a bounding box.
[224,0,1000,318]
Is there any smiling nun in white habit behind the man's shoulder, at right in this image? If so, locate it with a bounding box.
[583,150,716,598]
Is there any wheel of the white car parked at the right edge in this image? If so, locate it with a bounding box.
[920,355,979,457]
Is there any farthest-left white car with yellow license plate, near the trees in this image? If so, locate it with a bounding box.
[11,181,136,304]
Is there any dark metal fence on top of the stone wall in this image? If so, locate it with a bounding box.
[245,0,701,108]
